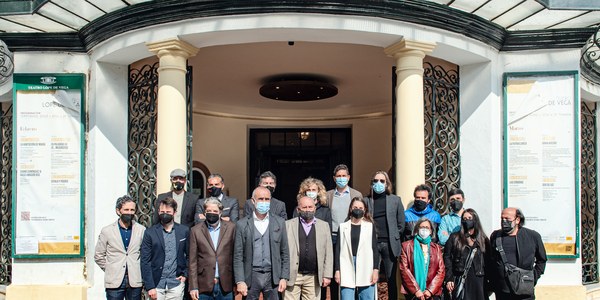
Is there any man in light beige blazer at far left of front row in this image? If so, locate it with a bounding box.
[94,195,146,300]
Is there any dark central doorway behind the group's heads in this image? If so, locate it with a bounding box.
[248,128,352,217]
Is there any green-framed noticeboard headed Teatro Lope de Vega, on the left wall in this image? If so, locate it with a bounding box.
[12,74,86,258]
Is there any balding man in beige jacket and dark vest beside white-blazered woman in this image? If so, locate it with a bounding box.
[284,196,333,300]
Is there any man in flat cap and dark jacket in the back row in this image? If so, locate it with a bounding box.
[152,169,198,227]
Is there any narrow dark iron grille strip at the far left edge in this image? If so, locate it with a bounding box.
[0,104,13,284]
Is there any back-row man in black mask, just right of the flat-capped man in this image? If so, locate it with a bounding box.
[194,174,240,224]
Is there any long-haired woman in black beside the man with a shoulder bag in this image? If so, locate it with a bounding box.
[444,208,490,300]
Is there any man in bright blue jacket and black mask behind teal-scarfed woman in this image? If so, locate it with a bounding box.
[404,184,442,241]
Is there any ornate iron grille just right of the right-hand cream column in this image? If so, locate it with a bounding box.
[423,62,460,213]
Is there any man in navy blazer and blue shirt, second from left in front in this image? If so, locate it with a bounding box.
[140,198,190,300]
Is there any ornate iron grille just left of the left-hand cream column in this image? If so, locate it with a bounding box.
[127,62,158,227]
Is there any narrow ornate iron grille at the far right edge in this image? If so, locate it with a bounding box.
[581,101,599,284]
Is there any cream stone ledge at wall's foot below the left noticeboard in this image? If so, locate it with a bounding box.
[6,284,88,300]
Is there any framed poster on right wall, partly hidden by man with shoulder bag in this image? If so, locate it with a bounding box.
[504,71,579,258]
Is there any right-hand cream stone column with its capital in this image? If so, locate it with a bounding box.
[384,40,435,207]
